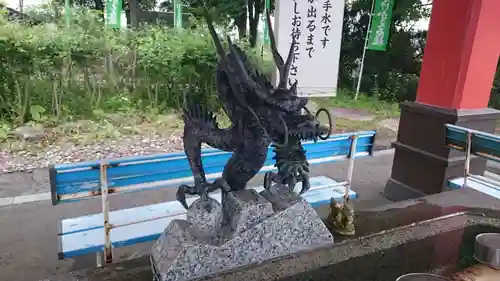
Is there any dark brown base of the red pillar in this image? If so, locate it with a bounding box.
[384,102,500,201]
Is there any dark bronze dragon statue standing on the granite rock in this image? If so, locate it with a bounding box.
[177,14,332,209]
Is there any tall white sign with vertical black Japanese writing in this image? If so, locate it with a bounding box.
[275,0,344,96]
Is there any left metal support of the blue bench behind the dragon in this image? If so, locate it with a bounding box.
[100,163,113,264]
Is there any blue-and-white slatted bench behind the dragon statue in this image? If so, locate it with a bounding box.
[50,131,376,265]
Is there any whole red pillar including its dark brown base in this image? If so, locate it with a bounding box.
[384,0,500,200]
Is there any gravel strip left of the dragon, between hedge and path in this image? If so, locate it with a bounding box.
[0,134,182,173]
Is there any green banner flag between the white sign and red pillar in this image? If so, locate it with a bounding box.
[367,0,394,51]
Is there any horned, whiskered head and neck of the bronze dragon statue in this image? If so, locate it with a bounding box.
[207,12,333,146]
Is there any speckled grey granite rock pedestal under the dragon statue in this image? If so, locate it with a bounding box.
[151,188,334,281]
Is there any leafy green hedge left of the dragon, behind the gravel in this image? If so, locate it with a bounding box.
[0,6,271,124]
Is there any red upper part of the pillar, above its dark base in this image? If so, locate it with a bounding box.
[417,0,500,109]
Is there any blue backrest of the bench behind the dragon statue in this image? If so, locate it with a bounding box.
[49,131,376,205]
